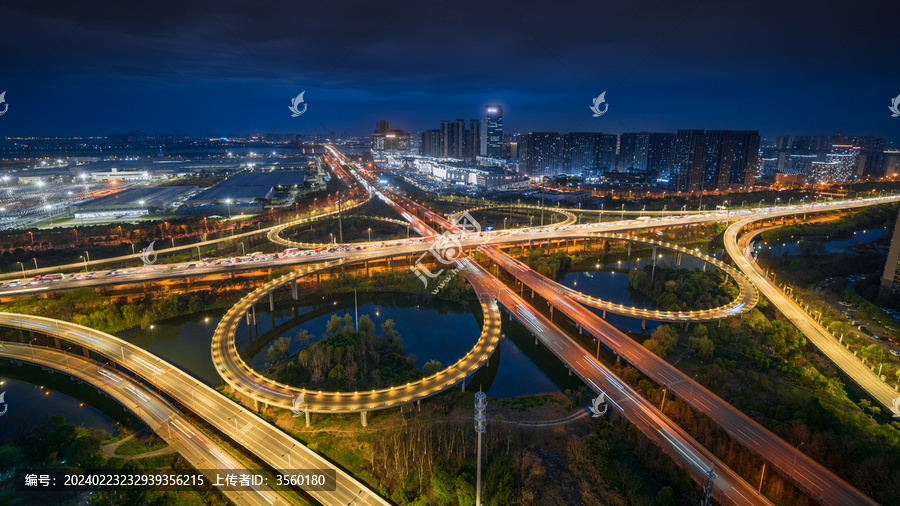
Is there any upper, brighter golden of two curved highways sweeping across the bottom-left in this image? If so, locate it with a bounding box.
[0,313,389,505]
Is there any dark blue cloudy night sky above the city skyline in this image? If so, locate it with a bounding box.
[0,0,900,140]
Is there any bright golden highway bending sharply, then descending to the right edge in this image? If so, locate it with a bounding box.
[725,213,898,409]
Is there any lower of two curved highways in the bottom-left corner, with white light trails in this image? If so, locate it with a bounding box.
[0,342,290,506]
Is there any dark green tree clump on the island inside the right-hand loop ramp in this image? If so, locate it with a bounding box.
[628,263,738,311]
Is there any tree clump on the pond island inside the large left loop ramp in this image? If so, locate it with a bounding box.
[266,313,426,391]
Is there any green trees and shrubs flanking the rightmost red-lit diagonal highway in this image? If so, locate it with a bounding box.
[648,310,900,503]
